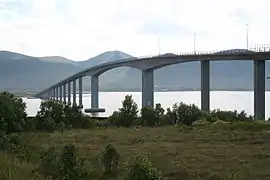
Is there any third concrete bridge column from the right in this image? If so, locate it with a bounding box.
[142,70,154,107]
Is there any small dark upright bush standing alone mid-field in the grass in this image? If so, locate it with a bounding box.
[101,144,120,173]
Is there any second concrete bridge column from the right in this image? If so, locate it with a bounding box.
[201,60,210,112]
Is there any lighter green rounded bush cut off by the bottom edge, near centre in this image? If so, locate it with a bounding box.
[126,155,163,180]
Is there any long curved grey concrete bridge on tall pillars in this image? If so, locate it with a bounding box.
[35,46,270,120]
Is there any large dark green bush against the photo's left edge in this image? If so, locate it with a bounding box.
[0,92,27,133]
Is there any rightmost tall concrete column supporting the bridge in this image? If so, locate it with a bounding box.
[254,60,265,120]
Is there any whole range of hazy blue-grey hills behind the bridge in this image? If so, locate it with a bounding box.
[0,50,270,92]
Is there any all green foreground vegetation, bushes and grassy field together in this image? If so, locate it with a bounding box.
[0,93,270,180]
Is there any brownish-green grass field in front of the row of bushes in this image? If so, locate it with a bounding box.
[0,125,270,180]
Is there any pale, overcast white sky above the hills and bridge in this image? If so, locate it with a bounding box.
[0,0,270,61]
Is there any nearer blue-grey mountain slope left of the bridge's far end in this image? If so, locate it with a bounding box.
[0,51,82,92]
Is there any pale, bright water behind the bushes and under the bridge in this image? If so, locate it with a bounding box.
[23,91,270,118]
